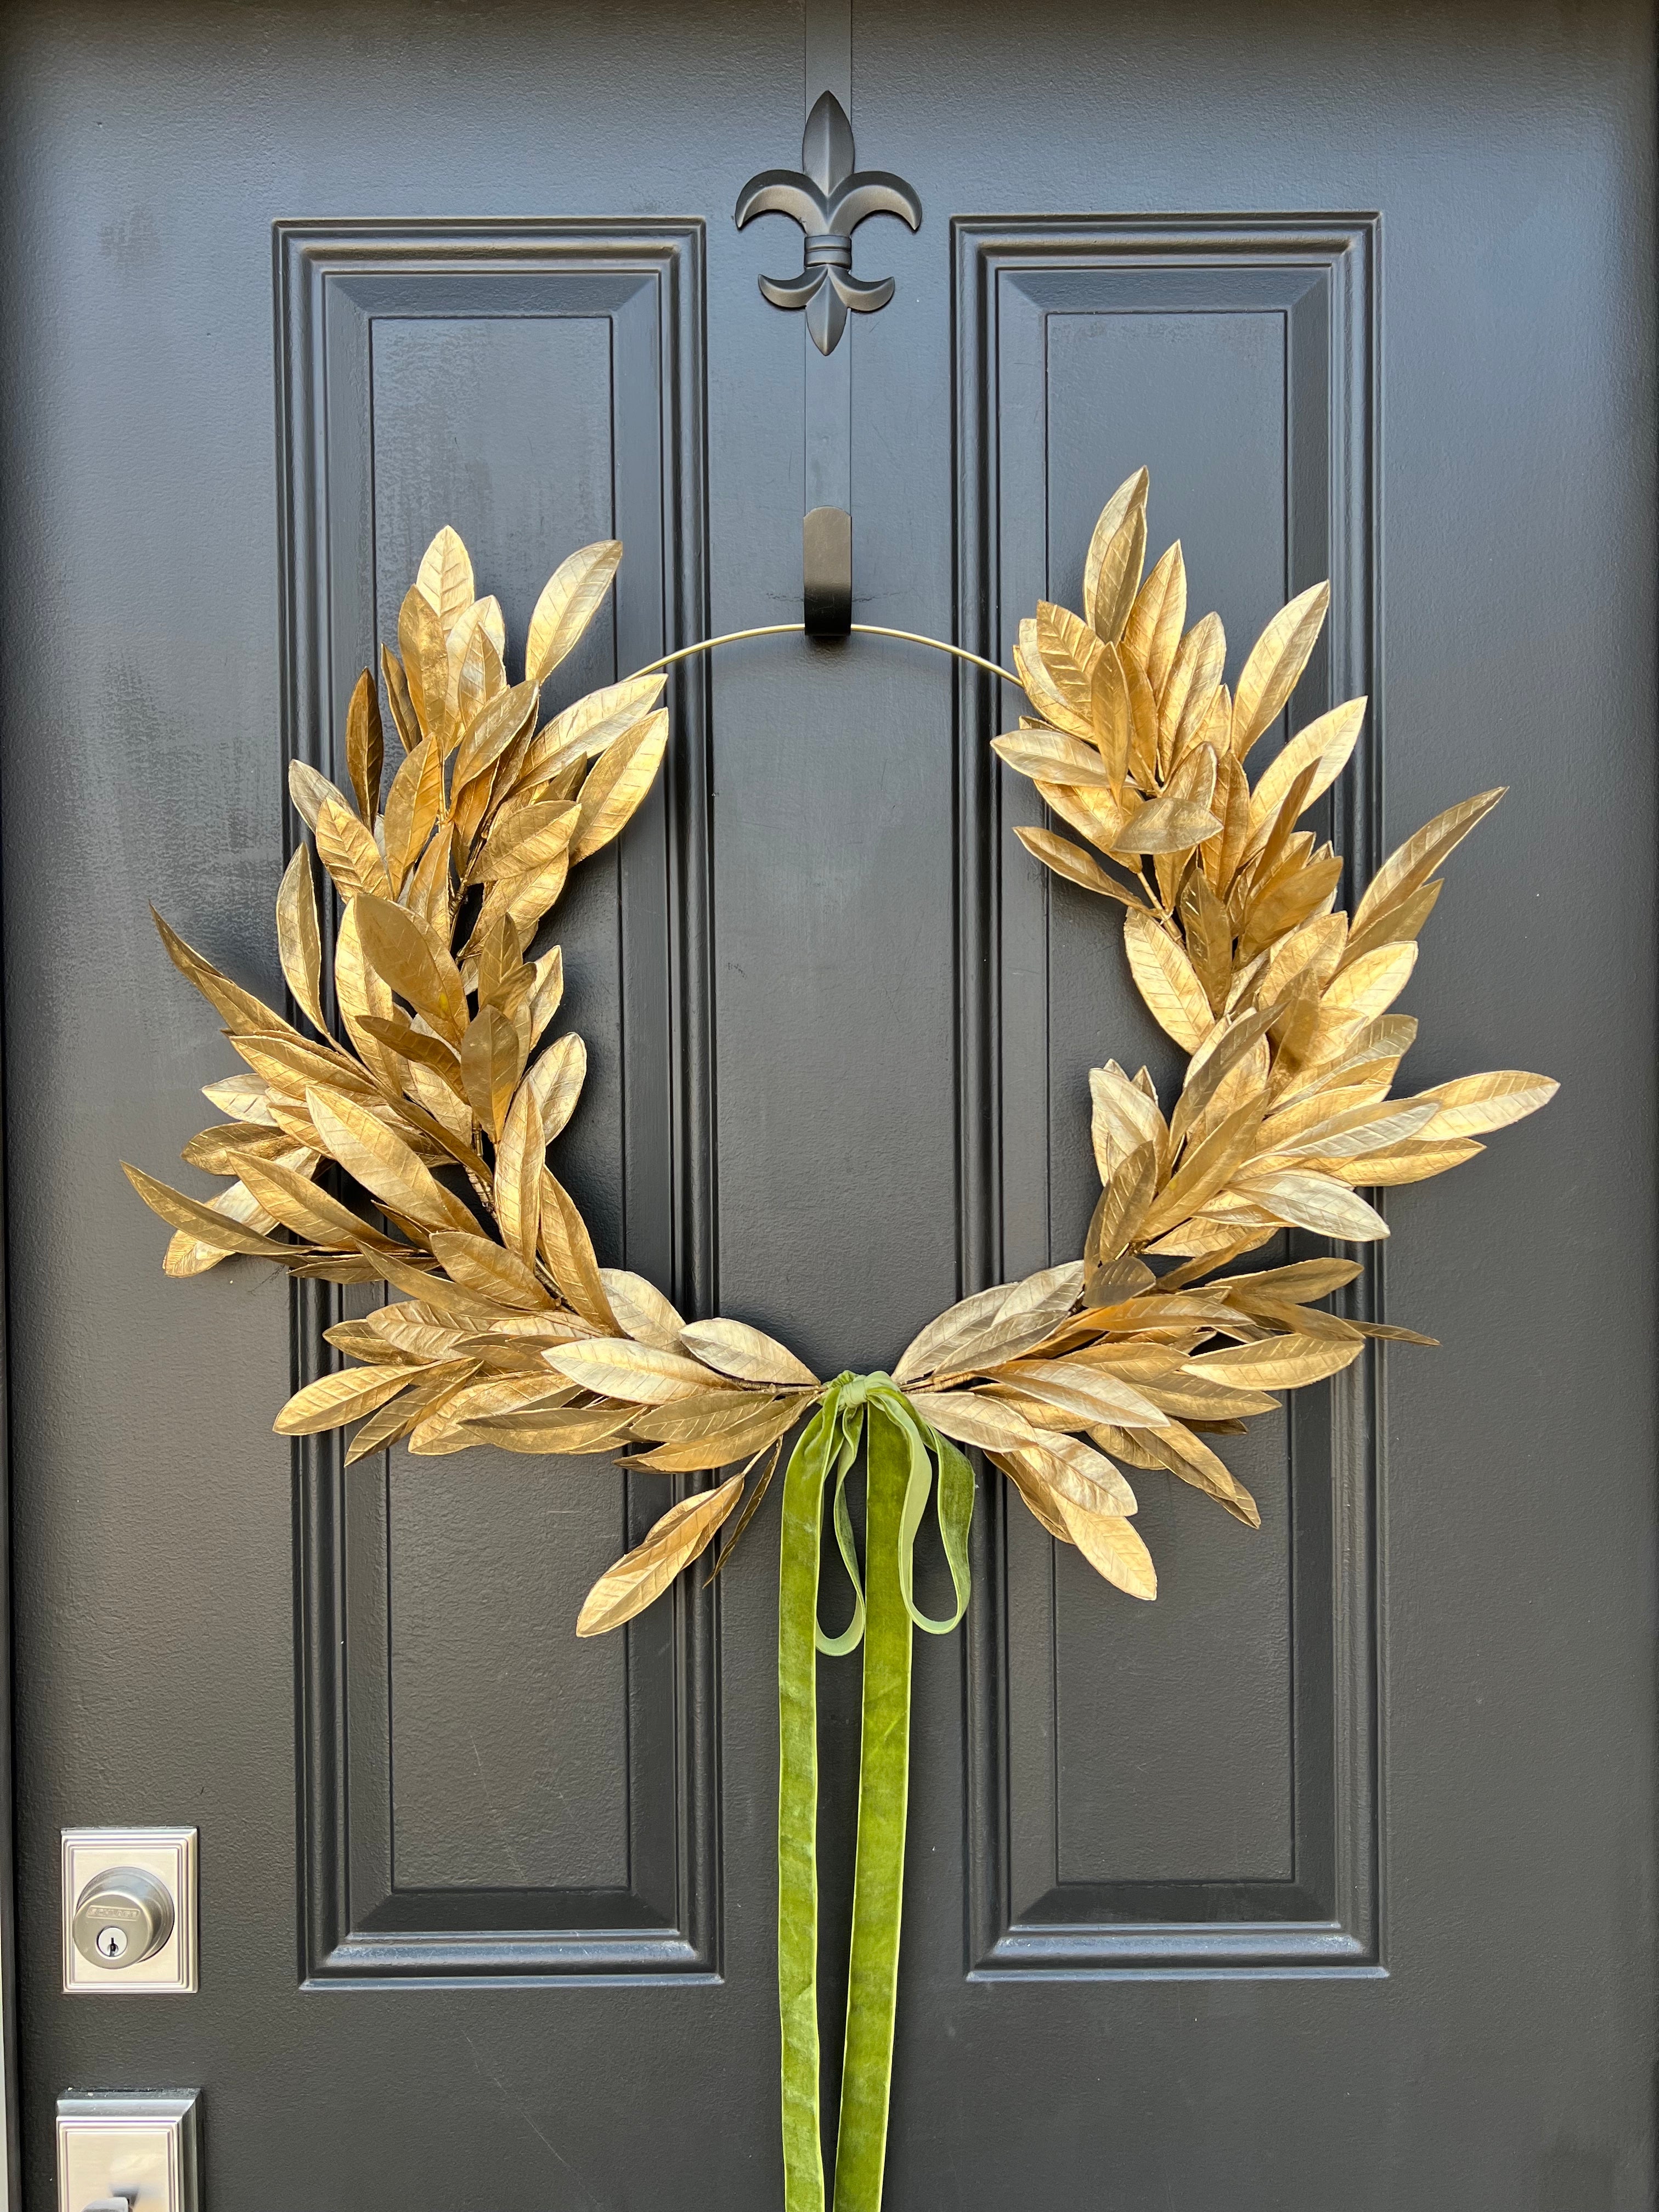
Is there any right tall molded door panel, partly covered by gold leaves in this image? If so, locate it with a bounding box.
[953,215,1383,1978]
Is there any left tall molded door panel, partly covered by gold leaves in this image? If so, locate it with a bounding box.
[274,219,719,1984]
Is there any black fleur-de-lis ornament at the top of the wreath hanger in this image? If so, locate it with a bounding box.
[737,93,922,354]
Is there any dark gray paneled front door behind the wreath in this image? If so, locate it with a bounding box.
[0,0,1655,2212]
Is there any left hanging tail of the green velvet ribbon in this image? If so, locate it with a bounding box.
[778,1387,840,2212]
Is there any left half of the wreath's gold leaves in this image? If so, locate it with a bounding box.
[126,529,819,1635]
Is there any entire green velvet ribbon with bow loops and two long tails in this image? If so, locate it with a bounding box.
[778,1374,973,2212]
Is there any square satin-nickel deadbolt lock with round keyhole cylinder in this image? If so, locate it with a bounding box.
[62,1827,197,1995]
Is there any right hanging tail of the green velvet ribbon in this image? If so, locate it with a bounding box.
[834,1400,911,2212]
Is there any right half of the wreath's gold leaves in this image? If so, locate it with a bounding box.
[916,469,1558,1597]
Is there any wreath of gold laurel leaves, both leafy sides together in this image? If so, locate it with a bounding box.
[126,469,1555,1635]
